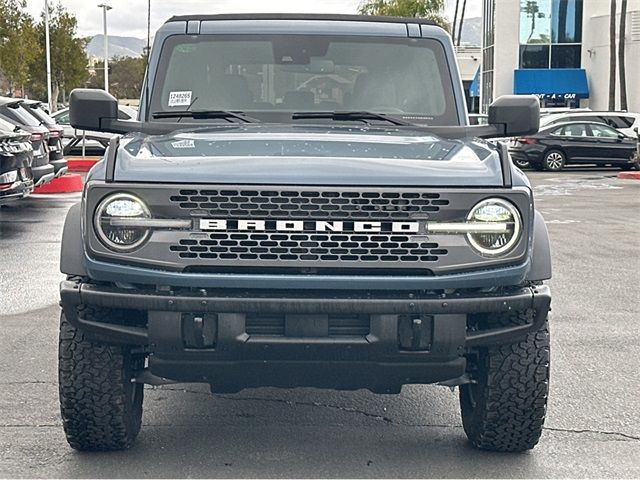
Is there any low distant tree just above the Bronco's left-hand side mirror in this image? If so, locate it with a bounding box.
[87,56,147,99]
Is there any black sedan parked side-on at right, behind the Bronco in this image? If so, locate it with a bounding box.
[509,122,640,172]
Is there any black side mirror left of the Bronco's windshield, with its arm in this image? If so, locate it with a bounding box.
[69,88,141,133]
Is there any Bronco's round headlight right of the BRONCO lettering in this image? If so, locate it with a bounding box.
[467,198,522,256]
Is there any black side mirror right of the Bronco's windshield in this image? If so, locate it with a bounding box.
[489,95,540,137]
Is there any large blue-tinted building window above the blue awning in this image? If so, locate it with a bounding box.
[520,0,583,68]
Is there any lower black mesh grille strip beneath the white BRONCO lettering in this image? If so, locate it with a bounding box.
[169,232,448,263]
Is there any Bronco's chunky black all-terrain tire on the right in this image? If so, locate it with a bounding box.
[460,310,549,452]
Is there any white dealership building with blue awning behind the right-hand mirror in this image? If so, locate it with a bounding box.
[479,0,640,112]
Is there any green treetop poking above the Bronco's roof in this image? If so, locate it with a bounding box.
[358,0,449,30]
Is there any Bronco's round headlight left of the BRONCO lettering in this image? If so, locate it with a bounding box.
[94,193,151,252]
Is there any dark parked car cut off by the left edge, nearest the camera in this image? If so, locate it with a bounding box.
[0,119,33,205]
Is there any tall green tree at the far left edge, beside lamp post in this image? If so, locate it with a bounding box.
[0,0,42,92]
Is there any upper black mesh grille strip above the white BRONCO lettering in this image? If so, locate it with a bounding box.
[170,189,449,220]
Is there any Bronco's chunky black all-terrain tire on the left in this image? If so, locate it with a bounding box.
[58,307,144,450]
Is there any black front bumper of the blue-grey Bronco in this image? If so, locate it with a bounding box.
[61,281,551,392]
